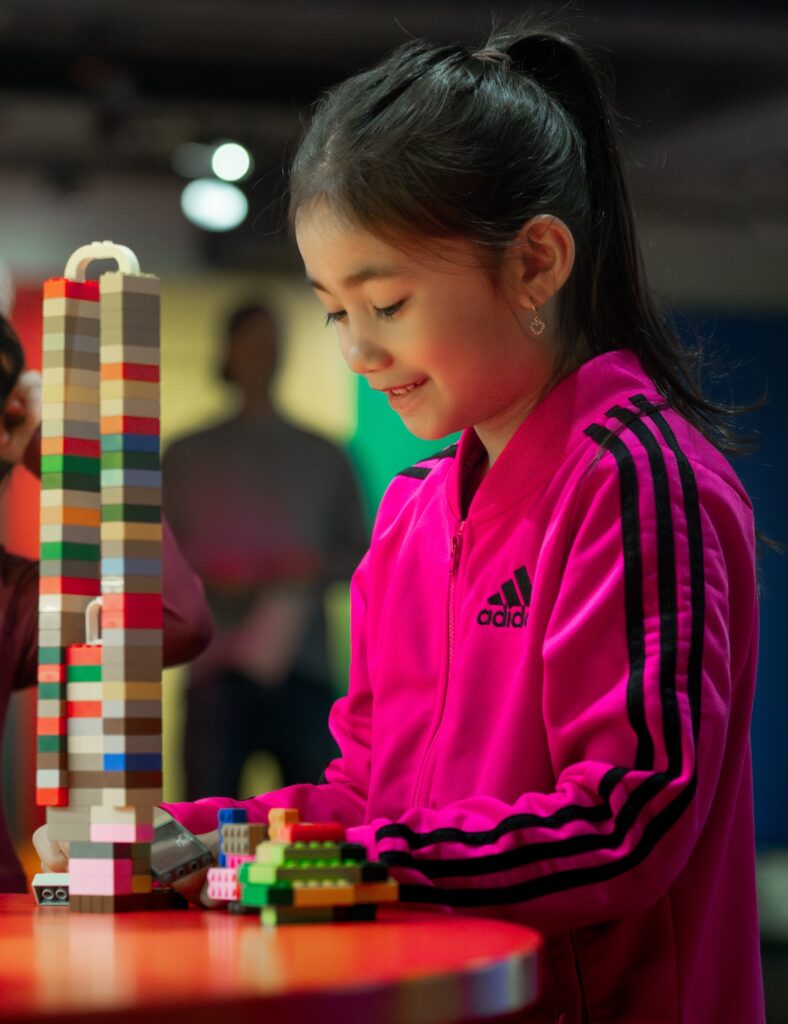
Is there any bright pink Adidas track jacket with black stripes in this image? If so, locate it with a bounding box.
[168,351,763,1024]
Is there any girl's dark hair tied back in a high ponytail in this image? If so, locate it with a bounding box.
[290,14,743,453]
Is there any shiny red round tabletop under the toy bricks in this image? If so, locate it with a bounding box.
[0,895,541,1024]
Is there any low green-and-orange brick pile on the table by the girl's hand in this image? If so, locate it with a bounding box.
[208,808,399,926]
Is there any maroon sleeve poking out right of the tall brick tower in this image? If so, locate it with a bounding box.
[162,517,214,666]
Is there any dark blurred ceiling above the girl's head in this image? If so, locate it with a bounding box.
[0,0,788,265]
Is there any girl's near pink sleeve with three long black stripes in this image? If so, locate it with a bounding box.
[339,428,756,932]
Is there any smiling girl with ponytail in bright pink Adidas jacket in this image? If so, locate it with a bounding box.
[47,18,763,1024]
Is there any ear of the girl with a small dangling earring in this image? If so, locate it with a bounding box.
[513,214,574,309]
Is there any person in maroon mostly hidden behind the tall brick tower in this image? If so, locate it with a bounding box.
[0,313,212,892]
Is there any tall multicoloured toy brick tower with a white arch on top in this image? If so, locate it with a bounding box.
[37,243,162,910]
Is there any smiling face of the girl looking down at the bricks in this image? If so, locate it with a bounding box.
[296,206,553,464]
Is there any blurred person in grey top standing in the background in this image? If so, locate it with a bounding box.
[164,303,367,800]
